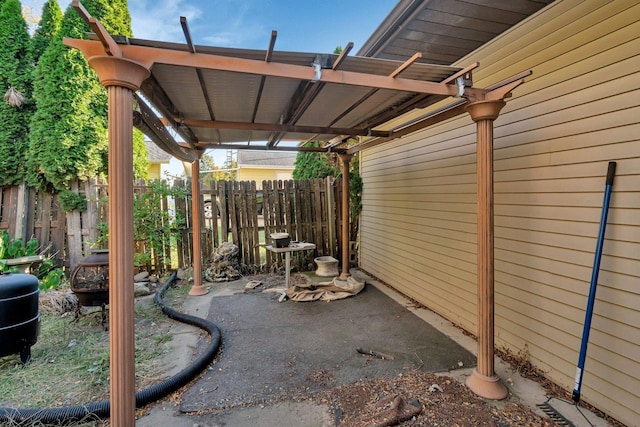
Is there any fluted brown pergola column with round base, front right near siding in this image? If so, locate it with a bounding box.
[466,99,509,400]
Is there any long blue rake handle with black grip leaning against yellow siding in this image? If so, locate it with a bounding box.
[571,162,616,404]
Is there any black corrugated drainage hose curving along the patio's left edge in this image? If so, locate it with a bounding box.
[0,272,221,426]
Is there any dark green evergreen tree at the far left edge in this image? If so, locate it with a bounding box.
[0,0,33,185]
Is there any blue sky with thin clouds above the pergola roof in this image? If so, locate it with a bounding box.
[22,0,397,174]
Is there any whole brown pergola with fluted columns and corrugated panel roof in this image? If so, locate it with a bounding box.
[64,1,530,426]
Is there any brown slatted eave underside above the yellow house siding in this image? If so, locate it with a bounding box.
[358,0,553,65]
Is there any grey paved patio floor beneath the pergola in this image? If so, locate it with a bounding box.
[136,270,607,427]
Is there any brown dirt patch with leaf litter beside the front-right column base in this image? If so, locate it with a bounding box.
[312,372,556,427]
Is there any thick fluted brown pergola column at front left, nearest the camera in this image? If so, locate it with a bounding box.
[89,56,149,426]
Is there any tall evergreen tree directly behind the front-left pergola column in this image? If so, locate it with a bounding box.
[26,0,146,191]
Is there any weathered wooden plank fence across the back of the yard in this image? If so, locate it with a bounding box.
[0,178,342,272]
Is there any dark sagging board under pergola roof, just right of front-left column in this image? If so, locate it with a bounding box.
[133,94,198,162]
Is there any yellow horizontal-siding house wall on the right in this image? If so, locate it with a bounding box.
[360,0,640,425]
